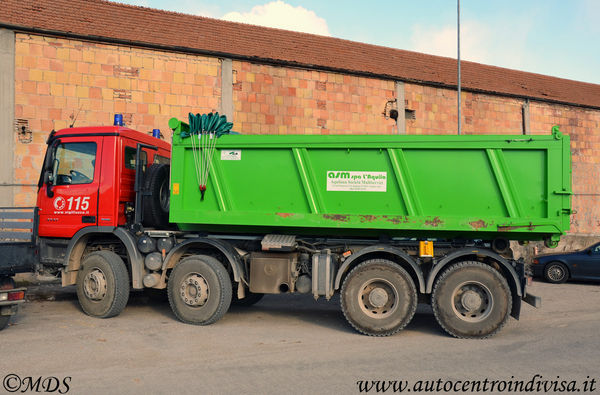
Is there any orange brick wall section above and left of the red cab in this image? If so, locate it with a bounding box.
[14,34,221,206]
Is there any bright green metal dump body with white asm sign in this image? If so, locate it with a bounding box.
[170,124,571,242]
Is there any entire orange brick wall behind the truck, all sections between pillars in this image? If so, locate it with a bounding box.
[8,34,600,235]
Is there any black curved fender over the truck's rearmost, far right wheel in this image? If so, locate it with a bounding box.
[425,248,523,319]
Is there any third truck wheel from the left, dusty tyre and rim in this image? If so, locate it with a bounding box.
[340,259,417,336]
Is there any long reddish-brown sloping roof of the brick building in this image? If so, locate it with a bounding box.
[0,0,600,108]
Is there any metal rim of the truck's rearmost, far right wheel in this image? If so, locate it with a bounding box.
[452,281,494,322]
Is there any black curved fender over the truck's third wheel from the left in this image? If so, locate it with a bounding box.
[335,245,425,293]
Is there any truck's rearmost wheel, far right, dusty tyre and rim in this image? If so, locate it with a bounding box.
[431,261,512,339]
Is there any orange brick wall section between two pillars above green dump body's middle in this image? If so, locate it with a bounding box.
[233,61,395,134]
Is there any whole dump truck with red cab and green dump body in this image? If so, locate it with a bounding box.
[0,116,571,338]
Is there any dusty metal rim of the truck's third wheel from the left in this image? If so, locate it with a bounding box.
[358,278,398,319]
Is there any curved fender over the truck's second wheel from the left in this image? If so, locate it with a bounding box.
[161,237,246,285]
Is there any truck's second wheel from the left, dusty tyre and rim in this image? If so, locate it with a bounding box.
[167,255,232,325]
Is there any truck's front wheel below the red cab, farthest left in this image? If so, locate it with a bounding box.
[77,251,129,318]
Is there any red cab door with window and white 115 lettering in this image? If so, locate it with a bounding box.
[38,136,103,237]
